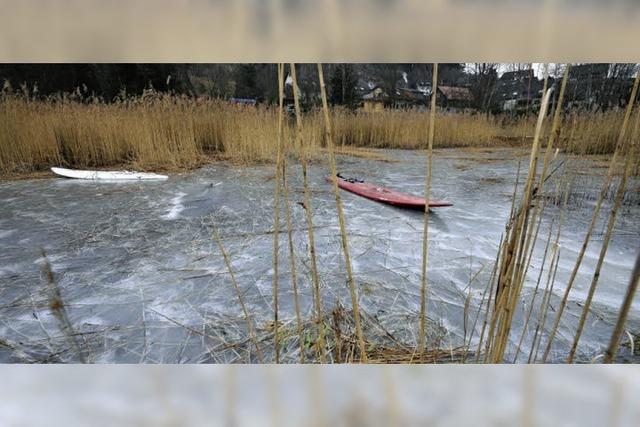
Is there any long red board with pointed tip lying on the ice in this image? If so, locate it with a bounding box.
[327,176,453,209]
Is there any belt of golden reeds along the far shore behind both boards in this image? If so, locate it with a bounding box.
[0,91,623,175]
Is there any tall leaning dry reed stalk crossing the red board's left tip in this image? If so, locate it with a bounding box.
[318,64,367,363]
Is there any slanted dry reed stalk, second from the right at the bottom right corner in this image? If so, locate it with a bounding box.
[567,101,640,363]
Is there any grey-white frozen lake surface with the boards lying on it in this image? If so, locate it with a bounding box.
[0,149,640,363]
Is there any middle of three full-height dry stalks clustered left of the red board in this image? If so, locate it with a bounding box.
[289,63,327,363]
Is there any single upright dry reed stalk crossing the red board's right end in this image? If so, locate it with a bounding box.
[418,63,438,354]
